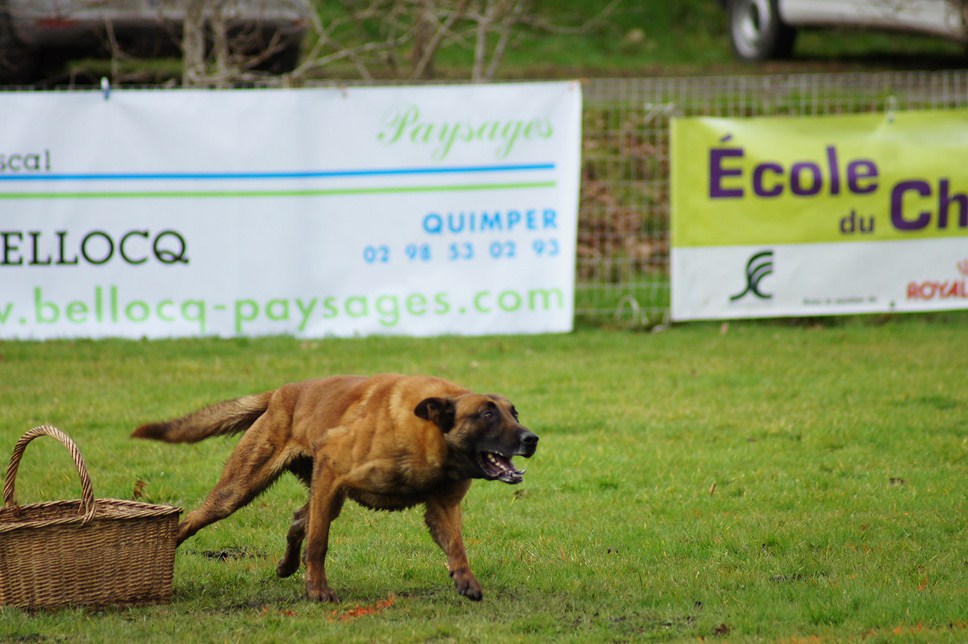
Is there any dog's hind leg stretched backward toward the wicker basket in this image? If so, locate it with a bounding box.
[178,417,292,544]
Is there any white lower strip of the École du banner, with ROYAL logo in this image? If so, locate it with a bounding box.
[672,239,968,320]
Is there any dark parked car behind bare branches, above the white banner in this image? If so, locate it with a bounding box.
[0,0,307,83]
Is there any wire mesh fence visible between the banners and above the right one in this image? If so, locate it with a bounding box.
[575,71,968,326]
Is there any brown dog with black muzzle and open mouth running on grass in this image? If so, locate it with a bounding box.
[133,374,538,601]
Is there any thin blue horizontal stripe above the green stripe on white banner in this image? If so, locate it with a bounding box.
[0,163,555,181]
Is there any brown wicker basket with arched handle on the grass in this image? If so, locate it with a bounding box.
[0,425,181,608]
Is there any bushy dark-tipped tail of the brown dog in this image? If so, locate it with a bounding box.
[131,391,275,443]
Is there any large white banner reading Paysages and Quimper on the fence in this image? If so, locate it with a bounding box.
[0,82,581,338]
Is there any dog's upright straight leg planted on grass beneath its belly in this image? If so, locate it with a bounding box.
[306,459,344,602]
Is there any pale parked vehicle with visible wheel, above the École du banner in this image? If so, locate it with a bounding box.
[719,0,968,61]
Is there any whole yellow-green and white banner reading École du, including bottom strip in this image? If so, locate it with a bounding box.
[670,110,968,320]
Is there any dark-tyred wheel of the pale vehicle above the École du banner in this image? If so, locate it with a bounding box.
[726,0,796,62]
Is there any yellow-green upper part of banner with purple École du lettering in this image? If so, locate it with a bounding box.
[671,110,968,248]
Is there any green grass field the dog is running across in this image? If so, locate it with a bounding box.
[0,316,968,642]
